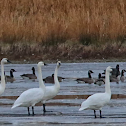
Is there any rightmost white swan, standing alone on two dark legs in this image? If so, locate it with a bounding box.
[79,66,112,118]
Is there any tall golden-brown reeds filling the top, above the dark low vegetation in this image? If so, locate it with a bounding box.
[0,0,126,45]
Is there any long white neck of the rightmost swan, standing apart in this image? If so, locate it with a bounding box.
[105,71,111,95]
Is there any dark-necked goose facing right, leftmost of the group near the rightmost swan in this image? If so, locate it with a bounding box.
[76,70,94,84]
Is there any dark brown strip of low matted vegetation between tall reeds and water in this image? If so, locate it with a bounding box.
[0,43,126,64]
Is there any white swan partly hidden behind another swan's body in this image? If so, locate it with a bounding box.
[42,61,61,113]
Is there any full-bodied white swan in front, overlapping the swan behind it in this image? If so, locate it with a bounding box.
[11,62,45,115]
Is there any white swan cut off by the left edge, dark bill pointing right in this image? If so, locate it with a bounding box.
[0,58,11,95]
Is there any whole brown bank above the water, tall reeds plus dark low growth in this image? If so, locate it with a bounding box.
[0,0,126,60]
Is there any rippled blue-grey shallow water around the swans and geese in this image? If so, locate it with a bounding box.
[0,62,126,126]
